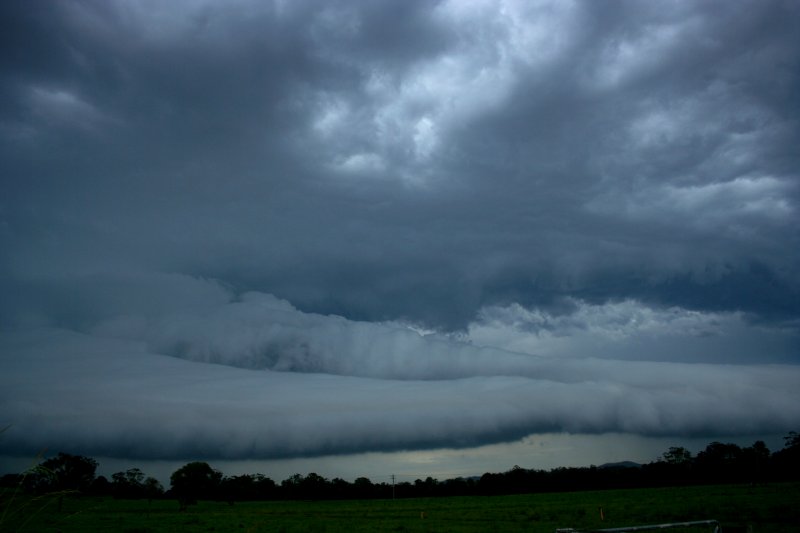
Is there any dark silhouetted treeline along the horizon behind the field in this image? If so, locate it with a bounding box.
[0,432,800,507]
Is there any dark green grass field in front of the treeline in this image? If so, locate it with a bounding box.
[0,483,800,533]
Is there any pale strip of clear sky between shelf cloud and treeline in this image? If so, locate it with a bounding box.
[0,433,784,488]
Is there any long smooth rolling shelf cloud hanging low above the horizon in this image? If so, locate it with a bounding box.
[0,286,800,459]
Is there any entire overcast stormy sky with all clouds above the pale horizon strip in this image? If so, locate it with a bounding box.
[0,0,800,482]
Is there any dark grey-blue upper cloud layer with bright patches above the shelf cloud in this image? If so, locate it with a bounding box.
[0,2,800,328]
